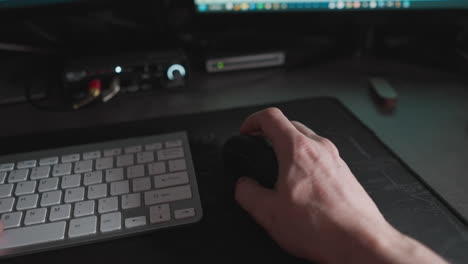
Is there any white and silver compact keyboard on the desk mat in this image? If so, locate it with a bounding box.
[0,132,202,257]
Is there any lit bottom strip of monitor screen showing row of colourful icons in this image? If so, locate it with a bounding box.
[195,0,468,12]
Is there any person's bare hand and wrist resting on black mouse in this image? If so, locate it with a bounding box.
[236,108,444,263]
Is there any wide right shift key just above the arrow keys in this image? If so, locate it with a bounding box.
[145,185,192,205]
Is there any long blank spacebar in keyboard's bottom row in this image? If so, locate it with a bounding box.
[0,221,66,249]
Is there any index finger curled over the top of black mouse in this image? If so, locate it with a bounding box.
[240,108,299,153]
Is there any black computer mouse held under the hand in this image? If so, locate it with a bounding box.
[223,135,278,188]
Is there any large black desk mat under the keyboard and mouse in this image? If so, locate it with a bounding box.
[0,98,468,264]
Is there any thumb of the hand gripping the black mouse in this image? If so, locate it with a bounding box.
[236,177,274,229]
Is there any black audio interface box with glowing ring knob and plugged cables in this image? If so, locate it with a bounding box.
[63,51,189,98]
